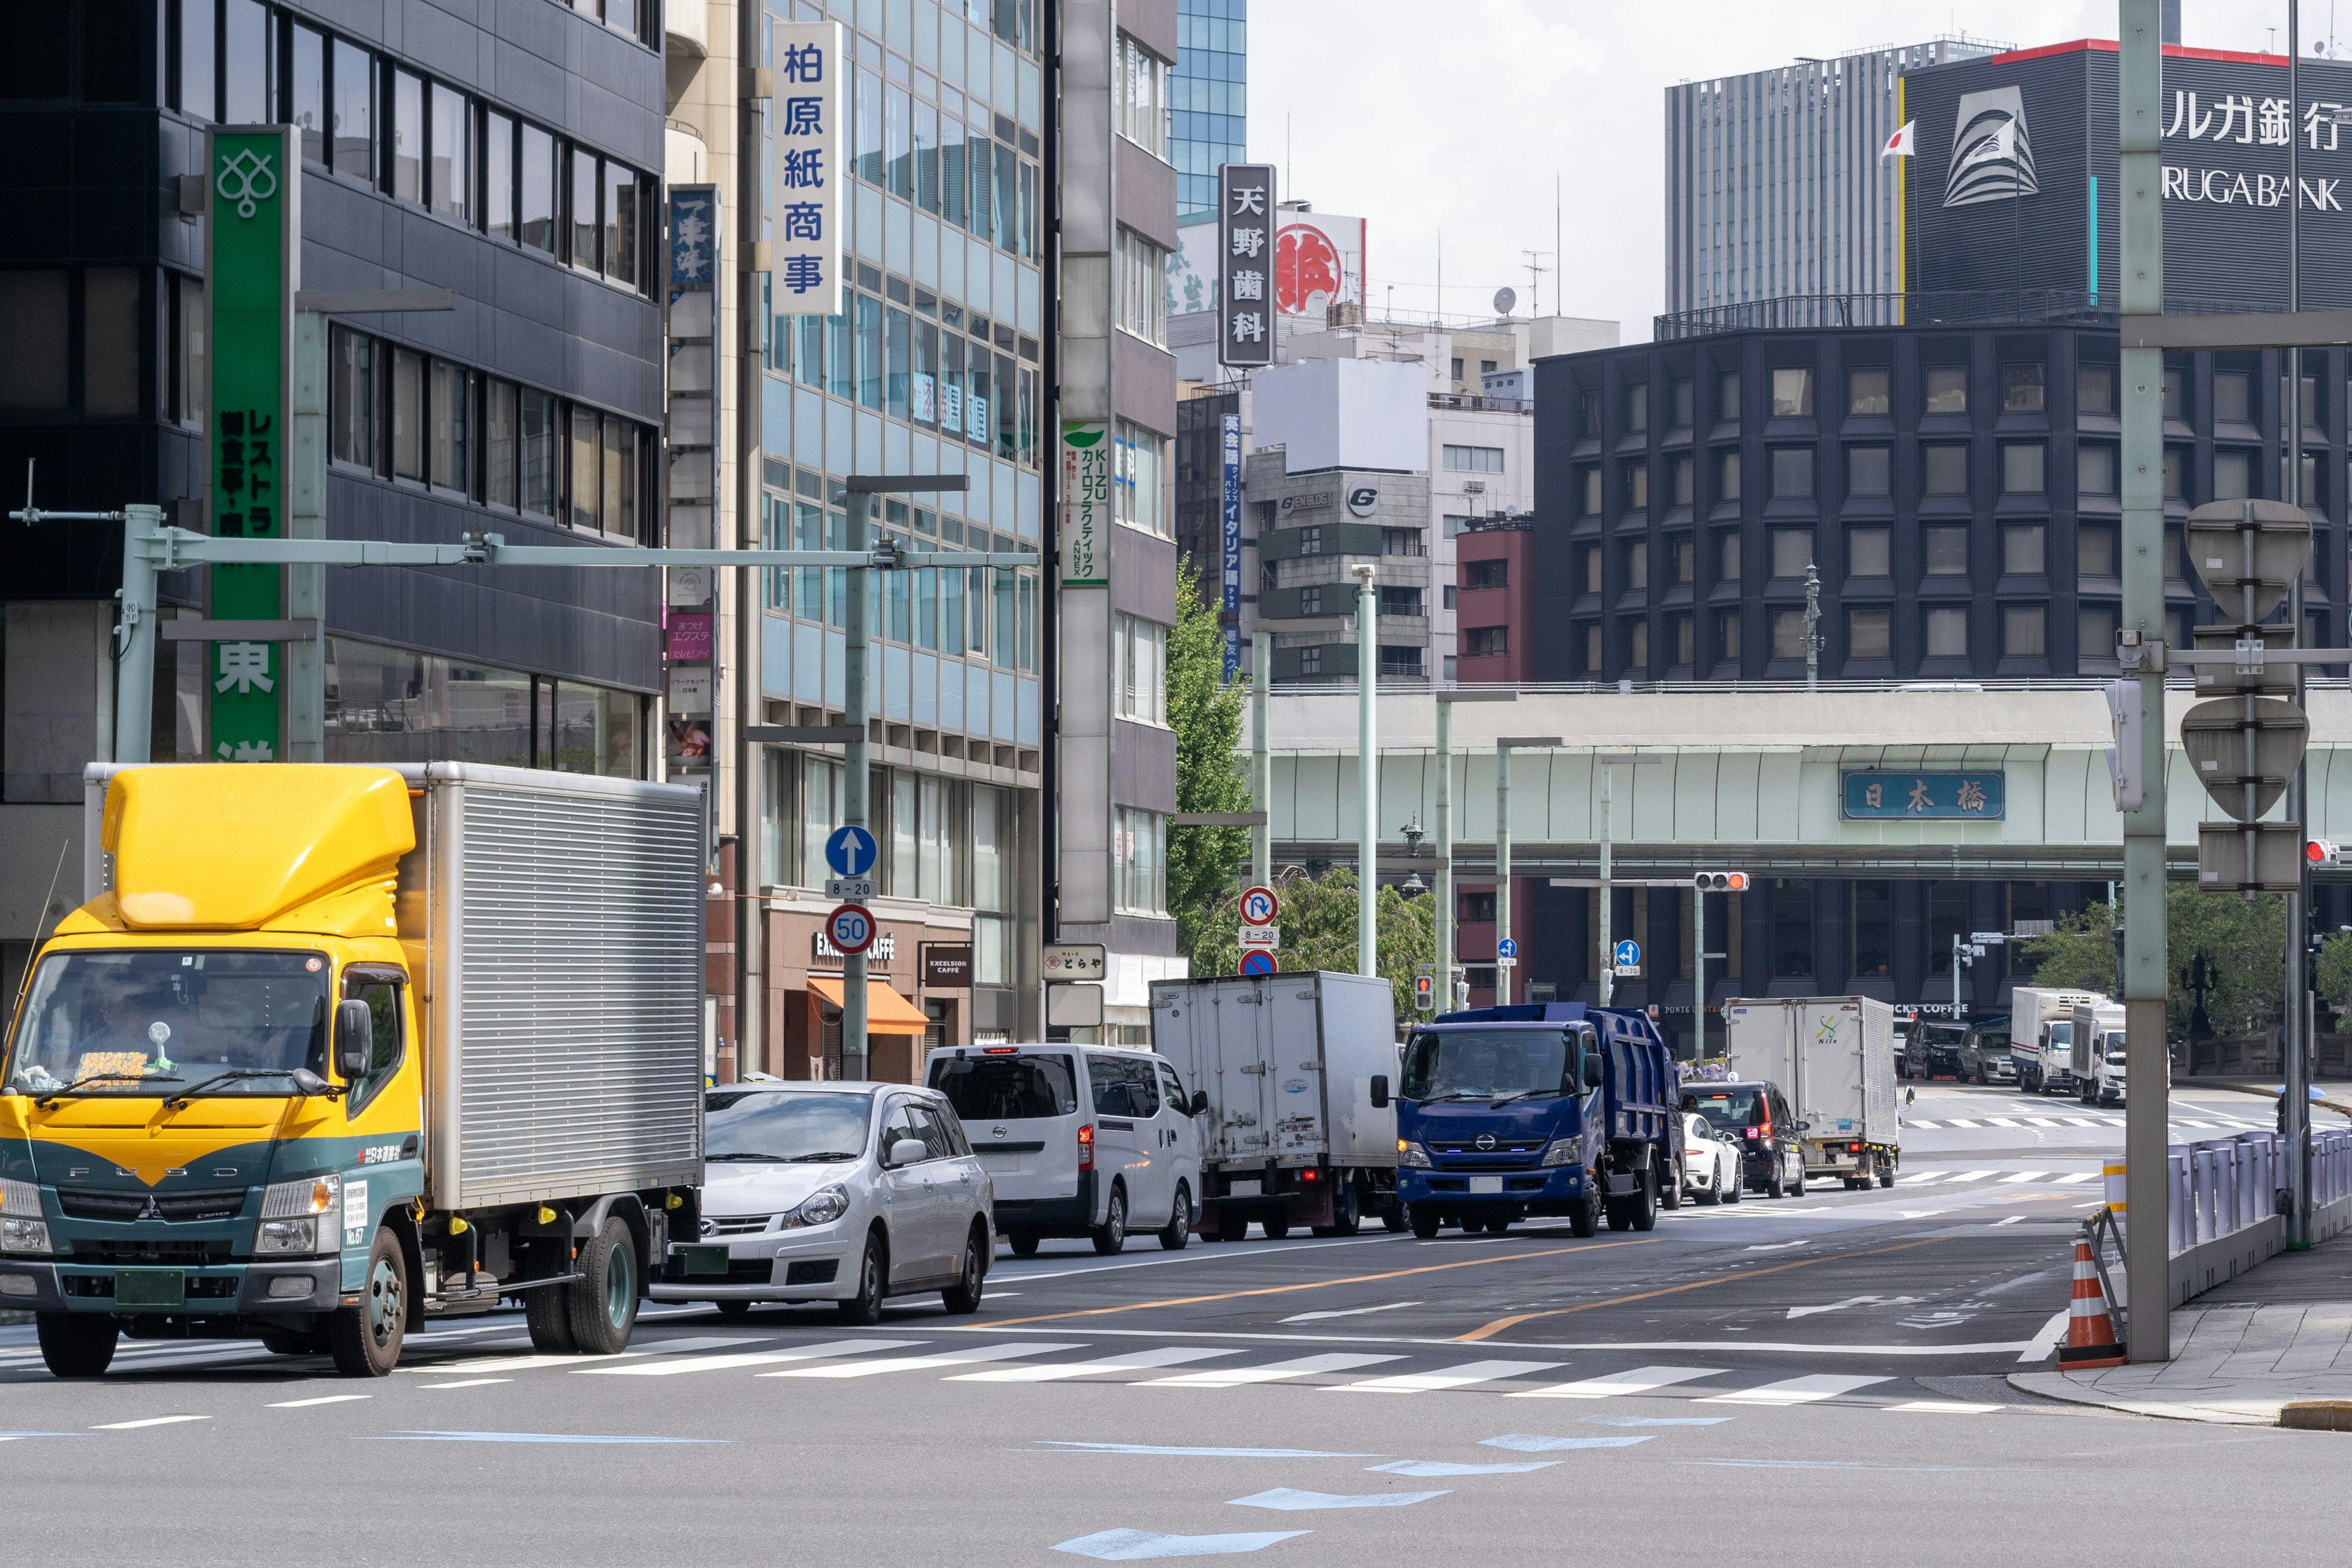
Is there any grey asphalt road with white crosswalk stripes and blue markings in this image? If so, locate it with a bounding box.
[0,1084,2352,1568]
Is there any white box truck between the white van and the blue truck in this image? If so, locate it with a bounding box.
[1153,971,1404,1242]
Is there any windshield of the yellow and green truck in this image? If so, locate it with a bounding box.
[7,948,327,1096]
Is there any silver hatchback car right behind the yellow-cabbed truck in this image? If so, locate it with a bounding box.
[649,1082,995,1324]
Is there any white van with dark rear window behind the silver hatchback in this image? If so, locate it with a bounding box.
[924,1044,1204,1257]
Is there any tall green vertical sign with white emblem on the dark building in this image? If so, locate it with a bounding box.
[205,124,301,762]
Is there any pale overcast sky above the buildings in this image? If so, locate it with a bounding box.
[1249,0,2352,341]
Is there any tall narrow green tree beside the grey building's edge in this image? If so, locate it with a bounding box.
[1167,557,1251,973]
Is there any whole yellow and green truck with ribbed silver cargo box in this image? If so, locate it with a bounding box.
[0,764,706,1378]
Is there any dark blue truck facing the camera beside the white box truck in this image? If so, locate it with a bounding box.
[1397,1001,1682,1237]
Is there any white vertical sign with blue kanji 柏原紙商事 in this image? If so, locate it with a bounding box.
[753,21,851,315]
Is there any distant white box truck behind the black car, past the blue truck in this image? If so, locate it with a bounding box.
[1724,997,1903,1187]
